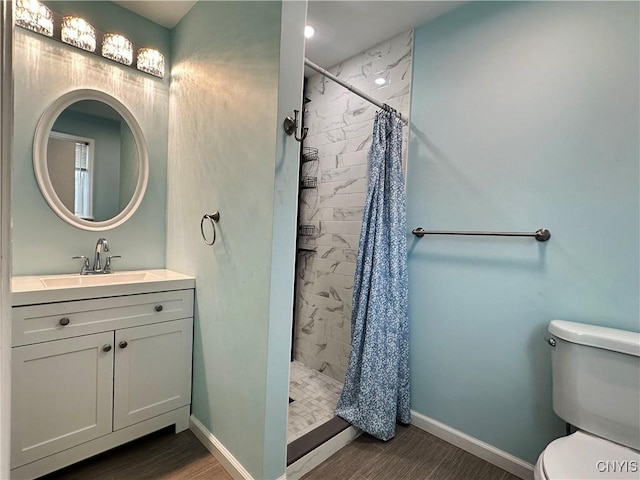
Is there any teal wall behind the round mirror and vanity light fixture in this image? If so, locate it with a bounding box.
[11,2,170,275]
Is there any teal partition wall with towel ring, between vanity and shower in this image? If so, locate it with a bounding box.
[167,2,304,479]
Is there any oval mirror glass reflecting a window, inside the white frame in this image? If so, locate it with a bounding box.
[47,100,138,222]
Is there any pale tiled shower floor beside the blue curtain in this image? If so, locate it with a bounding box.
[287,360,342,443]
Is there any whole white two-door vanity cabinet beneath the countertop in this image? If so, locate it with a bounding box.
[11,280,193,478]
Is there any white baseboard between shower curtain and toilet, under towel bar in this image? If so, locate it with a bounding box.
[411,410,533,480]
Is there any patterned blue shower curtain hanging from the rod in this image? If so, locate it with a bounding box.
[336,111,411,440]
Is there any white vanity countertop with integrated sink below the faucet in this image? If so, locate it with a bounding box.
[11,269,195,307]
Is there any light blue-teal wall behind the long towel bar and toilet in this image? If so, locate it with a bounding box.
[407,2,640,463]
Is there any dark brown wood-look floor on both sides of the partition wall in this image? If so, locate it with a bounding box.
[41,426,517,480]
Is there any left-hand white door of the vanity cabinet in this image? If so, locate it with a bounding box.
[11,332,113,468]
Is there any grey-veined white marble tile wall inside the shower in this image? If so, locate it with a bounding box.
[294,30,413,383]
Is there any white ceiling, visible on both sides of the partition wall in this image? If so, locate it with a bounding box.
[114,0,464,68]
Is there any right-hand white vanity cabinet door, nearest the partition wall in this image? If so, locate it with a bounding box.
[113,318,193,430]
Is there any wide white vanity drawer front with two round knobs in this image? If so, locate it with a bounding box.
[12,289,193,347]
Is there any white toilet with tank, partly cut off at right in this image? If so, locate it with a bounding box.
[534,320,640,480]
